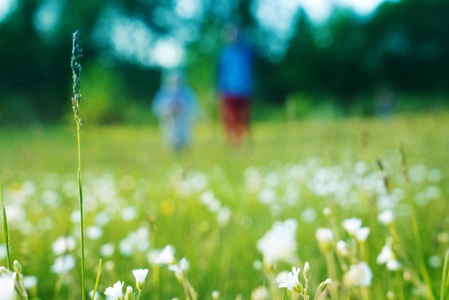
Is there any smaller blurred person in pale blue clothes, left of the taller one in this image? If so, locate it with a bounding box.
[153,70,198,153]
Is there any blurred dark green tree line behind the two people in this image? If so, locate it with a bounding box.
[0,0,449,124]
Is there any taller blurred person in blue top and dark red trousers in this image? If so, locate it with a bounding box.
[218,25,254,144]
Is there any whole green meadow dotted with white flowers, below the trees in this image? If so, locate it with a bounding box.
[0,112,449,299]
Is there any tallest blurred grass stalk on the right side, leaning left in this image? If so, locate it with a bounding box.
[399,143,435,299]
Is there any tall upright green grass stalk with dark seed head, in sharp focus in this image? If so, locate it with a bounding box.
[71,31,86,300]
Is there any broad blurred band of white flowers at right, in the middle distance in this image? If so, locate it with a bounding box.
[244,158,442,216]
